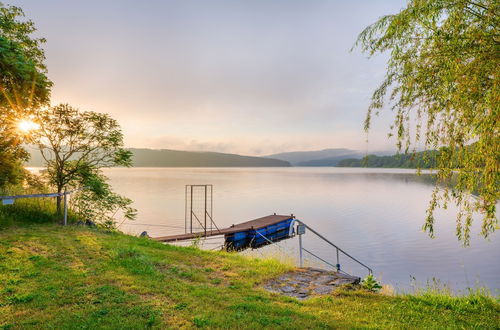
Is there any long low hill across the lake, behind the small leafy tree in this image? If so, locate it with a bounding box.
[26,148,290,167]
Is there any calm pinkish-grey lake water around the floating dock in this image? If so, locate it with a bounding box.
[106,168,500,291]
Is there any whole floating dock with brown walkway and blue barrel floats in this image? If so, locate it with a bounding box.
[155,214,295,250]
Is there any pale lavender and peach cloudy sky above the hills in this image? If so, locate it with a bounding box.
[8,0,404,155]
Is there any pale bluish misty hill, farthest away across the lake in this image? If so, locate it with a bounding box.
[265,148,364,166]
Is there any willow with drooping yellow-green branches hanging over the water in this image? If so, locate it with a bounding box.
[356,0,500,244]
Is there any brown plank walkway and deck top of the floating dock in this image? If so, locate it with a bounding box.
[154,214,294,242]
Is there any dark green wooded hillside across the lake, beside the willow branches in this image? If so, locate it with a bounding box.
[337,151,437,168]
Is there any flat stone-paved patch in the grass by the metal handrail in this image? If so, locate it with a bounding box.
[264,268,360,299]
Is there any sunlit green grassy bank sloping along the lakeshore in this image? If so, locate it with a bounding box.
[0,225,500,329]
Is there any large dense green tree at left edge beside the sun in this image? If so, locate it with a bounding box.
[0,2,52,187]
